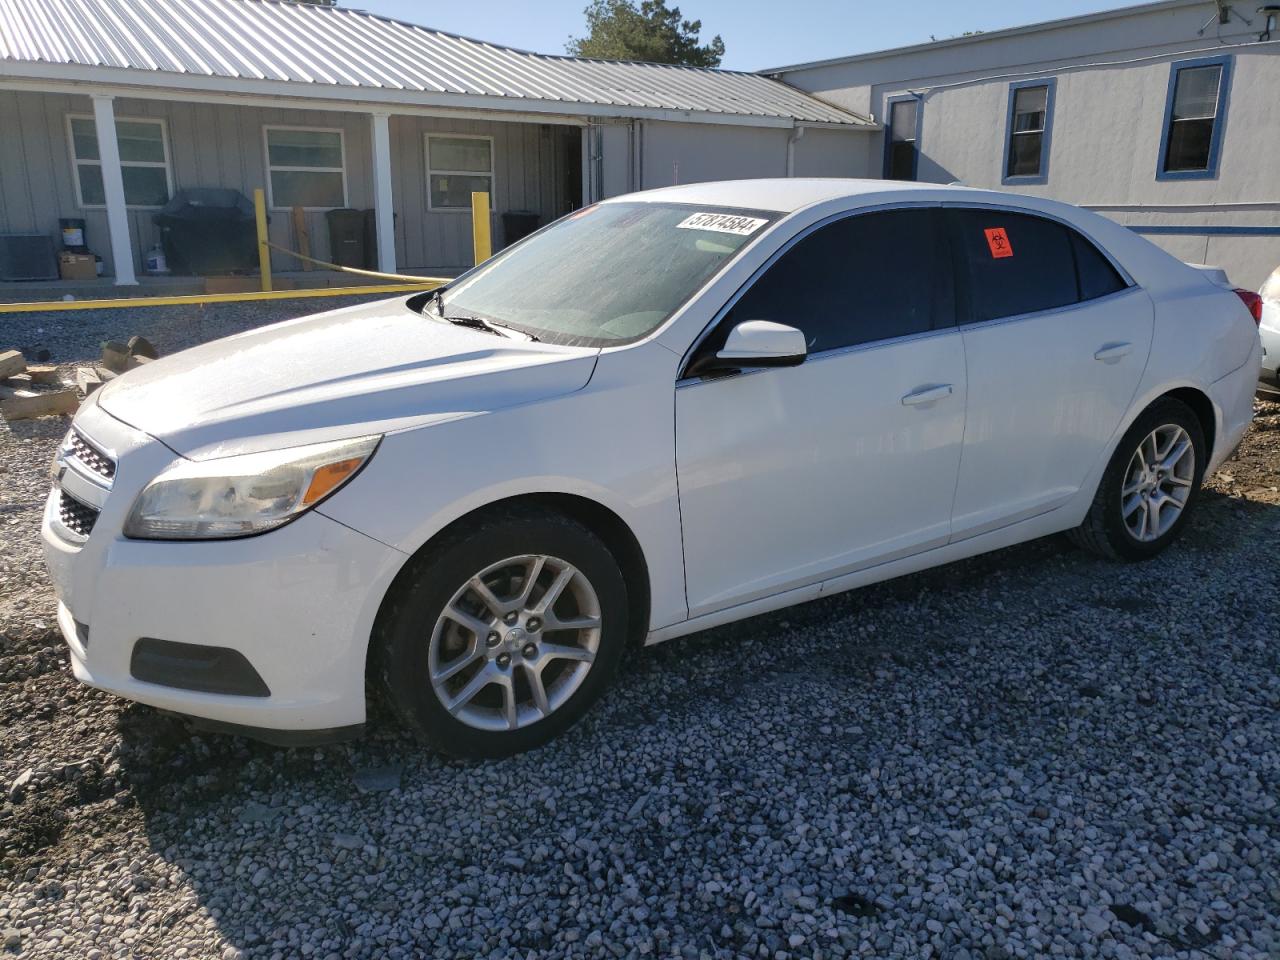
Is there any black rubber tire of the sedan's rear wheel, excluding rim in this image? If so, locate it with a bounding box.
[1069,398,1208,562]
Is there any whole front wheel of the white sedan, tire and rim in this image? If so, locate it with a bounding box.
[378,511,627,756]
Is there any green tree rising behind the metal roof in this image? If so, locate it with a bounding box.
[567,0,724,67]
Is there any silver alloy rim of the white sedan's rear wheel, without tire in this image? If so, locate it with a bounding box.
[1120,424,1196,543]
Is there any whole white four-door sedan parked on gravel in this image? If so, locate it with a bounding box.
[44,179,1261,756]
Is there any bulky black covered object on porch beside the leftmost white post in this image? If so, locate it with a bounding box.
[151,187,257,276]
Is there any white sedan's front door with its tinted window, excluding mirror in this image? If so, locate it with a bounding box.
[676,207,965,616]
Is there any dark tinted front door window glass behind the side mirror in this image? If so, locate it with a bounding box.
[721,209,952,353]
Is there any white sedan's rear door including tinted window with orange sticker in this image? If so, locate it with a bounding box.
[948,207,1153,539]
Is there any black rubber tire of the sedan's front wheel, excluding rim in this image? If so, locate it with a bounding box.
[372,508,628,758]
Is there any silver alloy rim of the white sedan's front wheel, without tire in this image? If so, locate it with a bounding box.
[428,554,600,731]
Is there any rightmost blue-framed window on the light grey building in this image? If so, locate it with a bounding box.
[1158,58,1231,179]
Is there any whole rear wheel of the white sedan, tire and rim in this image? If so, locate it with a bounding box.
[1071,398,1208,561]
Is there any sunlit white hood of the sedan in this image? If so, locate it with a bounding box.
[97,298,599,460]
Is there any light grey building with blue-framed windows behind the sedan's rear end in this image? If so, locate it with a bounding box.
[765,0,1280,289]
